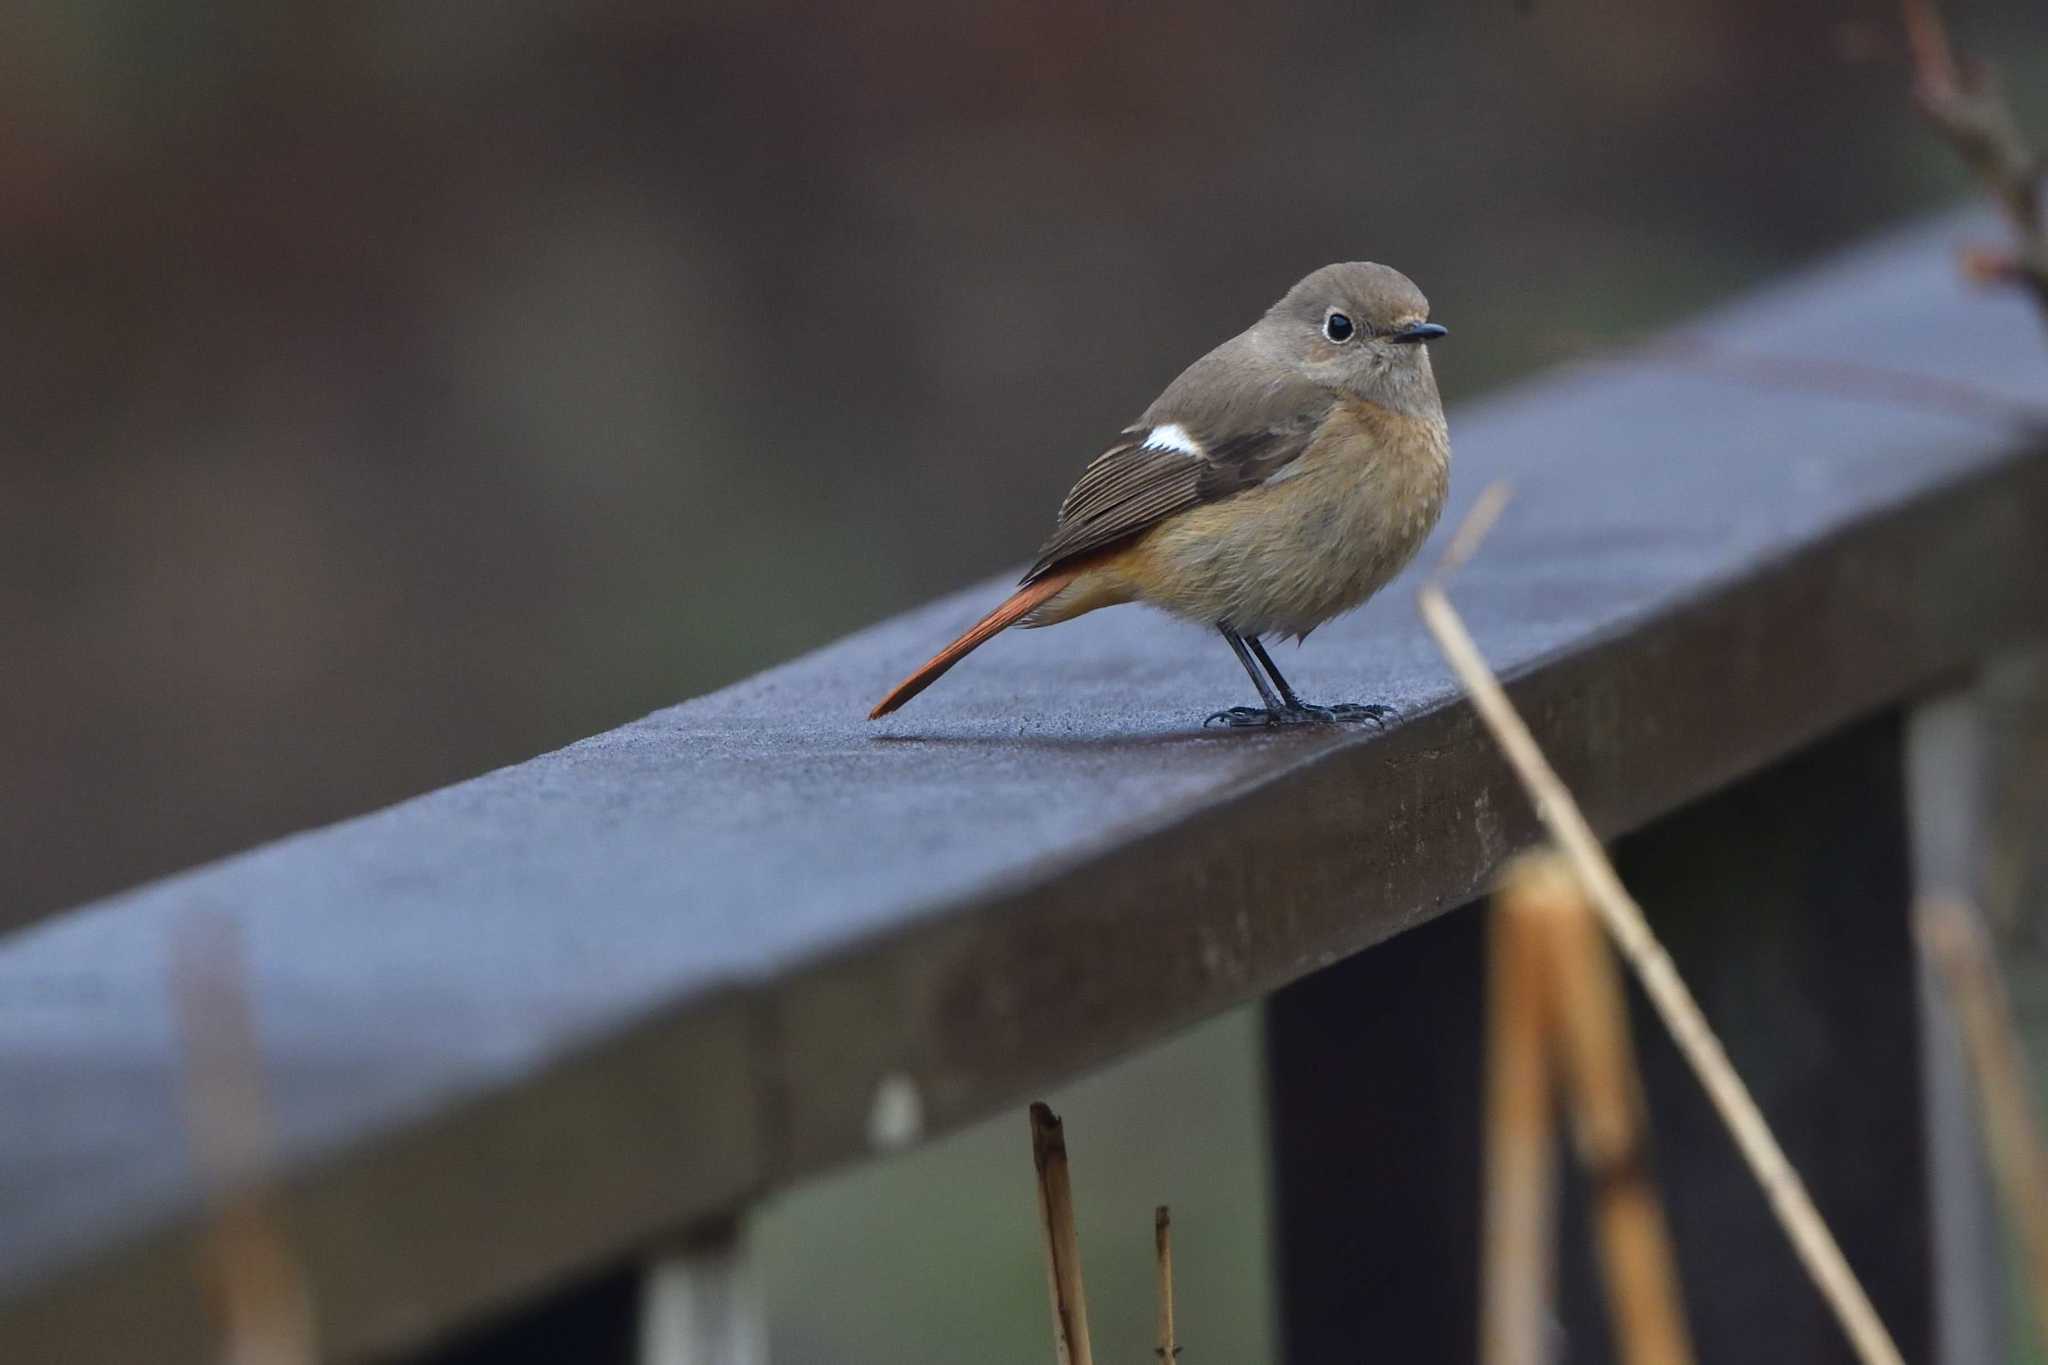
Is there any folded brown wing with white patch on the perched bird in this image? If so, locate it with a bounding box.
[1024,356,1331,583]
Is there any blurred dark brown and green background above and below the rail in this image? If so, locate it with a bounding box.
[0,0,2048,1361]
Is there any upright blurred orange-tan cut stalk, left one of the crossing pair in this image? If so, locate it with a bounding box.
[1479,870,1556,1365]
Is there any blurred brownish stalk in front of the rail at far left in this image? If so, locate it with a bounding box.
[170,915,313,1365]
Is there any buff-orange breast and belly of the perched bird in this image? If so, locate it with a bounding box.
[1116,405,1450,636]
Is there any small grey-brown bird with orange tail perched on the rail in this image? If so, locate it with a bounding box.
[868,262,1450,726]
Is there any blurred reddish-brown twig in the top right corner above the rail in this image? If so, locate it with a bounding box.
[1901,0,2048,317]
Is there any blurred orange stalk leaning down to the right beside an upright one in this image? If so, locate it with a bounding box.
[1524,853,1694,1365]
